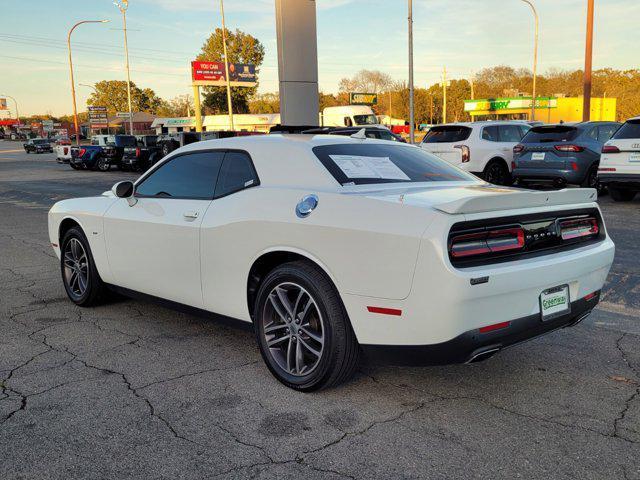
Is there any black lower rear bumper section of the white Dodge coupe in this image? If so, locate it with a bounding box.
[362,291,600,366]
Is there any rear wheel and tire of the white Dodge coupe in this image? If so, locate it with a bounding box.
[254,261,360,392]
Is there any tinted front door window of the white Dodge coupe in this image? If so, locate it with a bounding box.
[136,152,224,200]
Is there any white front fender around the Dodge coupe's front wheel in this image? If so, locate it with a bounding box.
[48,196,117,282]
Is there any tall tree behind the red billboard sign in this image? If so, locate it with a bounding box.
[197,28,264,114]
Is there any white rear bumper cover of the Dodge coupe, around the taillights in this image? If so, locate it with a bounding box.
[343,203,615,345]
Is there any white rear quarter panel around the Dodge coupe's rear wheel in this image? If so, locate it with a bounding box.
[201,185,432,320]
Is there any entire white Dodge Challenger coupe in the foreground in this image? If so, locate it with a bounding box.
[49,134,615,390]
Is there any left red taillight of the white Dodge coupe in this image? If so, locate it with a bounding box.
[449,227,524,258]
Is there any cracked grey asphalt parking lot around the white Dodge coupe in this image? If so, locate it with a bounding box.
[0,141,640,479]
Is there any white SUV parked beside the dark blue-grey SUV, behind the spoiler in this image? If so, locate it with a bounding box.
[420,121,531,185]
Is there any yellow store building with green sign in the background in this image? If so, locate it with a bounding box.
[464,97,616,123]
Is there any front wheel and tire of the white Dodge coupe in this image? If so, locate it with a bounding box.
[60,227,107,307]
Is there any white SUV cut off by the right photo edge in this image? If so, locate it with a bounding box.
[598,117,640,202]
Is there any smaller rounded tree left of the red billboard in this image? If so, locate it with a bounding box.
[87,80,162,115]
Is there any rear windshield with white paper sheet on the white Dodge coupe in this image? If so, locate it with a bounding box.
[313,143,475,185]
